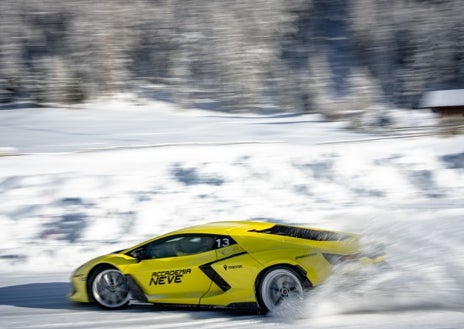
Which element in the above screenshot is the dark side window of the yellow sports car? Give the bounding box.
[143,234,216,259]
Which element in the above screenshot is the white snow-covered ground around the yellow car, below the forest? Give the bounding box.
[0,98,464,328]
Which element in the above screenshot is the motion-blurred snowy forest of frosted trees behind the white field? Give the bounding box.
[0,0,464,112]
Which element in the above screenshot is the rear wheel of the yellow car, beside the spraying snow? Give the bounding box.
[257,267,304,313]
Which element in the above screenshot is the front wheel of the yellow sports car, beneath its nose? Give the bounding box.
[90,269,130,310]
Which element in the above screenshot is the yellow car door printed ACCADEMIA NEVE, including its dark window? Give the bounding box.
[125,234,217,304]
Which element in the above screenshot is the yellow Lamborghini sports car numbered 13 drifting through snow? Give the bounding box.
[68,221,382,313]
